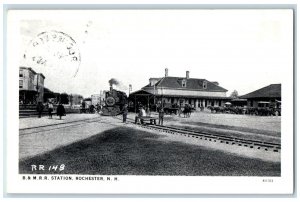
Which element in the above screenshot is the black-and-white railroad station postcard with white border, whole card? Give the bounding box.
[5,8,294,194]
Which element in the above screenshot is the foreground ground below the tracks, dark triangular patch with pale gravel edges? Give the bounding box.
[19,114,281,176]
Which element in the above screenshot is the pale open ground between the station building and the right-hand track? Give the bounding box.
[129,112,281,143]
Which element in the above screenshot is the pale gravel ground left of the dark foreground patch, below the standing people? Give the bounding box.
[19,116,115,159]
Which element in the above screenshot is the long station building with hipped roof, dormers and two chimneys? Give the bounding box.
[129,68,231,110]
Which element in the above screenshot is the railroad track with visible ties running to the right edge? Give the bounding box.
[111,116,281,152]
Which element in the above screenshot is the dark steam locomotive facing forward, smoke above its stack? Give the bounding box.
[102,87,127,116]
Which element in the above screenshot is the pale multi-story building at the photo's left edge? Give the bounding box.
[19,67,45,104]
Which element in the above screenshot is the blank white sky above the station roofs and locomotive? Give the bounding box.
[19,9,293,97]
